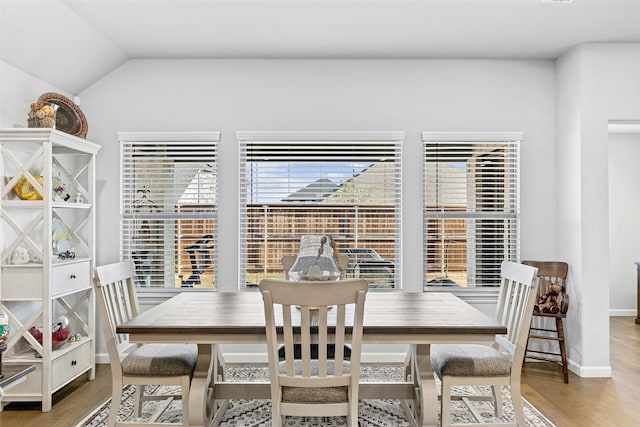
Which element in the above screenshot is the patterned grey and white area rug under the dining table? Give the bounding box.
[76,366,555,427]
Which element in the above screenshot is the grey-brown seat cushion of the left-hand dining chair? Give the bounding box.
[122,344,198,376]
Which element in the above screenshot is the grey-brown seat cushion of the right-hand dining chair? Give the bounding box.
[431,344,511,377]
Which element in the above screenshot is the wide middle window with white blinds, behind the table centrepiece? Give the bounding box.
[237,132,404,288]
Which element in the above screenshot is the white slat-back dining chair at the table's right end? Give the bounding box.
[431,261,538,427]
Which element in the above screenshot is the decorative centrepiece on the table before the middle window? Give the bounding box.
[289,235,340,281]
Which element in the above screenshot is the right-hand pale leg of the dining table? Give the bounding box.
[411,344,438,427]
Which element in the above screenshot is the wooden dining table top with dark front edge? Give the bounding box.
[117,291,506,336]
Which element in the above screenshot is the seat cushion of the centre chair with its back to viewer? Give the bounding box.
[279,360,351,403]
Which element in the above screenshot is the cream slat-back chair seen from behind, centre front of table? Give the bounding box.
[258,279,369,427]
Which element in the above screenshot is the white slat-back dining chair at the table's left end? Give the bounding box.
[95,260,198,427]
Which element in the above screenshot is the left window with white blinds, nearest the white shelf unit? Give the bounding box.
[118,132,220,288]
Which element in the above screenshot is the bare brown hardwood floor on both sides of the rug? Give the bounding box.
[0,317,640,427]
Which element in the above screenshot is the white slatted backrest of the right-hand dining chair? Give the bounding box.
[496,261,538,369]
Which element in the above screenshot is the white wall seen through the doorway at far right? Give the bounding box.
[609,133,640,316]
